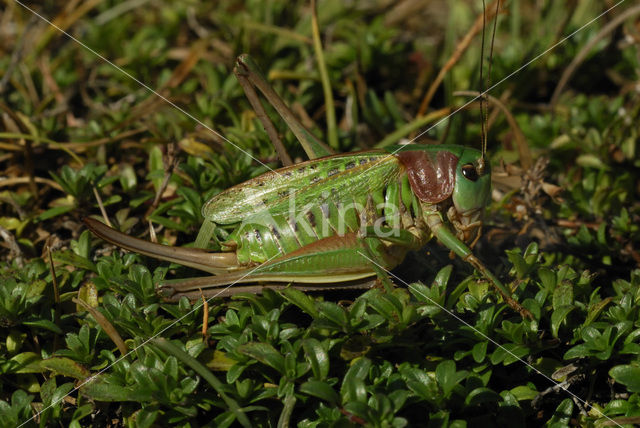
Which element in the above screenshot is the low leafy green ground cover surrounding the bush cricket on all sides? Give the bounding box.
[0,0,640,427]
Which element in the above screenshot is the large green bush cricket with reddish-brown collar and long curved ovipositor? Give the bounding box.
[85,55,531,317]
